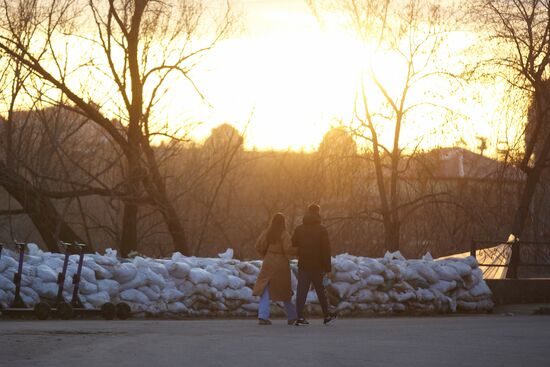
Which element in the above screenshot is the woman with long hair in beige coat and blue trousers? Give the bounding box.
[253,213,297,325]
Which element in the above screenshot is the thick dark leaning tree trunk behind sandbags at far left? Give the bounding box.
[0,162,84,252]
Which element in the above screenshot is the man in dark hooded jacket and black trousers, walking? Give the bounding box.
[292,204,336,325]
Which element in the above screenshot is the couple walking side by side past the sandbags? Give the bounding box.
[253,204,336,325]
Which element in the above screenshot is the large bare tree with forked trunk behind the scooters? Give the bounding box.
[0,0,232,255]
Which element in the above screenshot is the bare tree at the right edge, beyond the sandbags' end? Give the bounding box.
[472,0,550,276]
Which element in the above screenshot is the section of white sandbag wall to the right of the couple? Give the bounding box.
[326,252,493,313]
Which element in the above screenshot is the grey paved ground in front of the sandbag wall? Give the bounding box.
[0,315,550,367]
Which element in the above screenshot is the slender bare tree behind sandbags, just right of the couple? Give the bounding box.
[310,0,462,251]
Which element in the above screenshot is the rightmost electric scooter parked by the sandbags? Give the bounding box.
[71,243,132,320]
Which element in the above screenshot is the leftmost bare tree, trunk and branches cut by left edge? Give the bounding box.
[0,1,86,251]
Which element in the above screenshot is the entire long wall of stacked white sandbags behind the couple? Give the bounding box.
[0,244,493,316]
